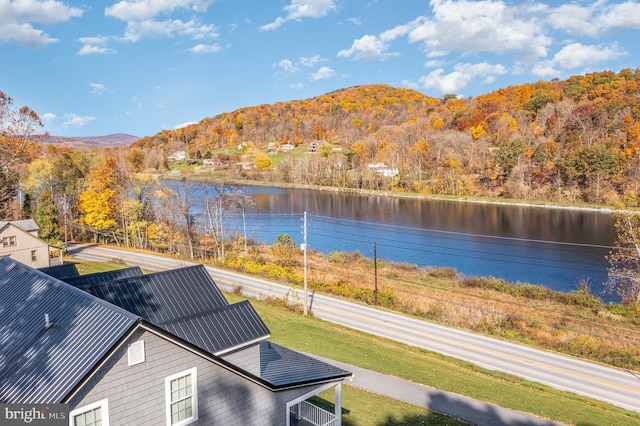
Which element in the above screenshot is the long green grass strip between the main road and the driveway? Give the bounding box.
[226,294,640,426]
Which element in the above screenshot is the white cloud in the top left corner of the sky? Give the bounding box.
[0,0,83,48]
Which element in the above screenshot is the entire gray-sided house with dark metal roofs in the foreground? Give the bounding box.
[0,257,352,426]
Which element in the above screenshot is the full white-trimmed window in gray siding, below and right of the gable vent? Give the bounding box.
[164,368,198,426]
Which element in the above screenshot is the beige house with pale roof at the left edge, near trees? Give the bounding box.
[0,219,62,268]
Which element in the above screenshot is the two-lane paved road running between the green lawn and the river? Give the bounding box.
[65,246,640,412]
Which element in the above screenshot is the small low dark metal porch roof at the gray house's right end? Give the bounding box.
[260,341,352,389]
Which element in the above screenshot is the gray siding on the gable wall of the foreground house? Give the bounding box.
[69,330,324,426]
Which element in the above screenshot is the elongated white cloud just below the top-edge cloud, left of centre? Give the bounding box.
[124,19,219,42]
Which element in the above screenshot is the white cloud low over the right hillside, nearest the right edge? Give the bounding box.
[532,43,627,77]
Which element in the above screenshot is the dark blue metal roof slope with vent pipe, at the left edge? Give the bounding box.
[0,257,139,404]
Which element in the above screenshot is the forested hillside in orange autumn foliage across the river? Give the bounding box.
[132,69,640,204]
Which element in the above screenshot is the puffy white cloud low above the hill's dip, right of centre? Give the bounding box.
[419,62,507,93]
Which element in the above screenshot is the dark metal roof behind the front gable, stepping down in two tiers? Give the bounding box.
[80,265,269,354]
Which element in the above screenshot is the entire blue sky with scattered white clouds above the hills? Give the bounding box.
[0,0,640,137]
